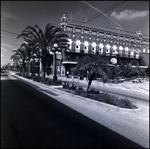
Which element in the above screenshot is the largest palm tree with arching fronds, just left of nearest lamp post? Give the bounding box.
[17,23,68,80]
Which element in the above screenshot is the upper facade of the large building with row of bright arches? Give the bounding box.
[61,16,149,62]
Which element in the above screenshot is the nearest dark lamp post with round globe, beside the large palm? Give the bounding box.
[53,43,58,84]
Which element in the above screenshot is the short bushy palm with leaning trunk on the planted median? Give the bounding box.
[75,55,109,91]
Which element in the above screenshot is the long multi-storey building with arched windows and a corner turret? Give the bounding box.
[48,15,149,75]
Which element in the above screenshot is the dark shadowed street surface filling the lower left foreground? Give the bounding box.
[1,76,141,148]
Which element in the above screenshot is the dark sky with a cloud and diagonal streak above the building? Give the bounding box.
[1,1,149,65]
